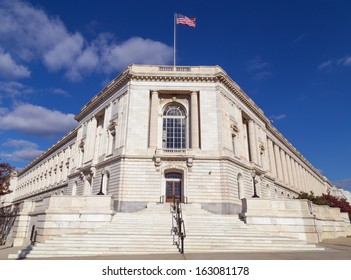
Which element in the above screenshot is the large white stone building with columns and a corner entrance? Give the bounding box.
[2,65,350,254]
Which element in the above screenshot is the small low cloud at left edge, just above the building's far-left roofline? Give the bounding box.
[0,139,43,162]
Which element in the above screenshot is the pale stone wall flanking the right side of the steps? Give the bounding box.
[241,199,351,243]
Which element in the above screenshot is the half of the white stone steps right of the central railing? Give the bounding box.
[182,202,324,253]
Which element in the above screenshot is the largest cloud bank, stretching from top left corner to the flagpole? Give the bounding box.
[0,0,172,81]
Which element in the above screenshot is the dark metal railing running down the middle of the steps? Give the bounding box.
[171,198,186,254]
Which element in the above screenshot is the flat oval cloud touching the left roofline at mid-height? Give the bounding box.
[0,104,76,136]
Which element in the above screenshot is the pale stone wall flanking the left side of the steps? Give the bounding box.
[13,196,114,246]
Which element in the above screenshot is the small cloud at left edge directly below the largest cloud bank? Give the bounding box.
[0,48,30,79]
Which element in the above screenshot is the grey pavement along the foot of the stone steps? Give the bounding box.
[0,237,351,260]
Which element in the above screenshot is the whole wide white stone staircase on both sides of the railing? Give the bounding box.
[9,204,322,259]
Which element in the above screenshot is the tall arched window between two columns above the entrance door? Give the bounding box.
[162,104,186,150]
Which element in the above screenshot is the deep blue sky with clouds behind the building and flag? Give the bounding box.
[0,0,351,190]
